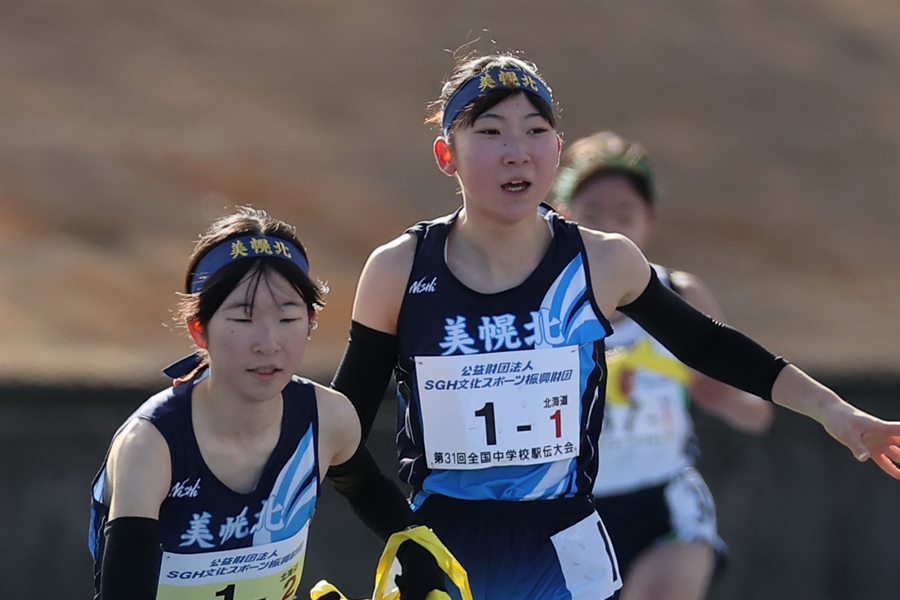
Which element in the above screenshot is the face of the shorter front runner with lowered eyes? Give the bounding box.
[206,271,309,401]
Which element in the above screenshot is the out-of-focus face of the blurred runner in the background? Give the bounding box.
[566,175,656,248]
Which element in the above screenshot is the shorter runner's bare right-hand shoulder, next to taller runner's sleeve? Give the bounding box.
[313,383,361,475]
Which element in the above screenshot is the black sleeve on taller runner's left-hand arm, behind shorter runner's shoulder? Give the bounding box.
[331,321,397,445]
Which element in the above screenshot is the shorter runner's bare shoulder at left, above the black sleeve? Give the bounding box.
[107,418,172,519]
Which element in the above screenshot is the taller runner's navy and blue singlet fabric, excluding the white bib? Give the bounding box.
[398,207,611,503]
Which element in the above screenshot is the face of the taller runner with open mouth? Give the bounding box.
[452,93,561,220]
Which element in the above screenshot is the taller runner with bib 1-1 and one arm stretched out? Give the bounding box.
[332,54,900,600]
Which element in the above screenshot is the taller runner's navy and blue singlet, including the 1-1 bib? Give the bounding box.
[397,206,611,507]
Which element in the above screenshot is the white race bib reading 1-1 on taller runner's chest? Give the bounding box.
[415,346,581,469]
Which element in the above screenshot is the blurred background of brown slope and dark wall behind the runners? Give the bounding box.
[0,0,900,600]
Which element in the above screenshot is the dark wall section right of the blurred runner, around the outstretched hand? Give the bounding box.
[697,376,900,600]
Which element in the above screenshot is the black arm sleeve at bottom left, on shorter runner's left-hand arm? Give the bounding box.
[100,517,162,600]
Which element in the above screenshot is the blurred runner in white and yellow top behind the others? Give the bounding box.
[555,131,773,600]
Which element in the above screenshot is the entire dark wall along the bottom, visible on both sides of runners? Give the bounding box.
[0,377,900,600]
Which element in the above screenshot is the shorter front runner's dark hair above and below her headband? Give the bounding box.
[176,206,327,336]
